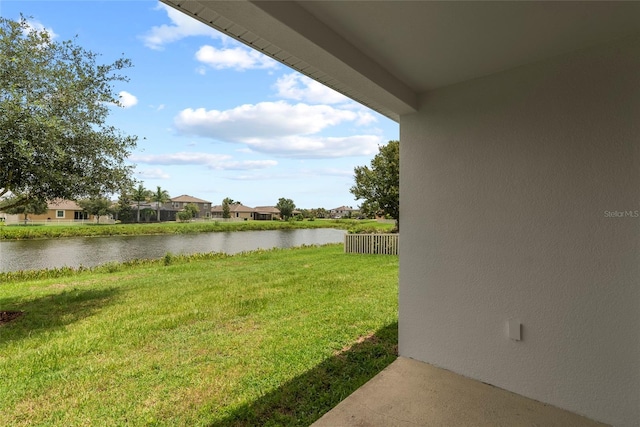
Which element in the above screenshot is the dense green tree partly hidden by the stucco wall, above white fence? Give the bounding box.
[349,141,400,231]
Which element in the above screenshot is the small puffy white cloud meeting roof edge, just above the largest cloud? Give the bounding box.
[275,73,352,104]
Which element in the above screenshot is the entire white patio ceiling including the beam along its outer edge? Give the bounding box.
[161,0,640,121]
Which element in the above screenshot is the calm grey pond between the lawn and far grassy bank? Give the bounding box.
[0,228,345,272]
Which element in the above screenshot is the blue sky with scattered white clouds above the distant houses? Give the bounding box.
[0,0,399,209]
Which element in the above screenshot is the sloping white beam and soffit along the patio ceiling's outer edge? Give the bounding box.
[161,0,418,121]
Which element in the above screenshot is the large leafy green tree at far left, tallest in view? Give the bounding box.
[0,17,137,210]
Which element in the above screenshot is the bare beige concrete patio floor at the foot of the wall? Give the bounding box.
[312,357,605,427]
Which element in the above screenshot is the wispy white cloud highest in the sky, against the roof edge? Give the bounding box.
[140,3,221,50]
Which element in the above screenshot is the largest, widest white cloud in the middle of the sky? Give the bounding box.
[174,101,381,158]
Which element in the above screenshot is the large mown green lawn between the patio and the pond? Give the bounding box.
[0,245,398,427]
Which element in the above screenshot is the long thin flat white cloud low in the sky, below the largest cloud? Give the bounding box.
[129,152,278,170]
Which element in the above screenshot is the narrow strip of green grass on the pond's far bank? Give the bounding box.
[0,220,393,240]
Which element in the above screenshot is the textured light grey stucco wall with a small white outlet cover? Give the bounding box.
[400,39,640,426]
